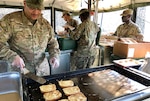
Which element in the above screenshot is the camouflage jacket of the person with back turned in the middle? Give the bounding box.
[70,19,99,57]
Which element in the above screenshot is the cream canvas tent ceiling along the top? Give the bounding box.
[0,0,150,12]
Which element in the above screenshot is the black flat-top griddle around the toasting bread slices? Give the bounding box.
[24,64,150,101]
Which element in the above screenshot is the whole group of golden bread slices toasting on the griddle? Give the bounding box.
[40,80,87,101]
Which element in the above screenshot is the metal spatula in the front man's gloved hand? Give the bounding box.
[22,68,46,84]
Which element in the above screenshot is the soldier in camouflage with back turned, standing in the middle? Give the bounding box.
[70,9,99,70]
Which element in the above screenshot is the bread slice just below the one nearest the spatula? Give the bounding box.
[43,90,62,101]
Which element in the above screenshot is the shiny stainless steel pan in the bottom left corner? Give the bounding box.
[0,72,23,101]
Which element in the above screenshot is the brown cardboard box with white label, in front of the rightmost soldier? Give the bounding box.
[113,41,150,58]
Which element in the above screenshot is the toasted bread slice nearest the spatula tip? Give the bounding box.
[39,84,56,93]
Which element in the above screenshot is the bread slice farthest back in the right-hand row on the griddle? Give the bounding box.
[58,80,74,88]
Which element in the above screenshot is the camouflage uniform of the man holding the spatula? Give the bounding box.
[0,11,59,75]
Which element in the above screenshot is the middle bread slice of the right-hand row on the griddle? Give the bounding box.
[63,86,80,96]
